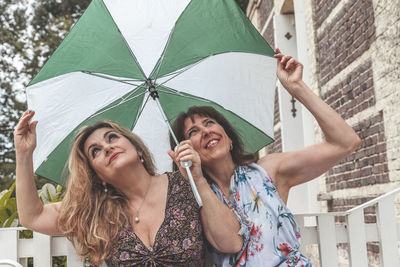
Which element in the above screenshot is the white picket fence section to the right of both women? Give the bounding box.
[294,188,400,267]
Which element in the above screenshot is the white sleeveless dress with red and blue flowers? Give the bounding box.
[211,163,311,267]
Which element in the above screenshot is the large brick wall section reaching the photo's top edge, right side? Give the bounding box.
[314,0,375,85]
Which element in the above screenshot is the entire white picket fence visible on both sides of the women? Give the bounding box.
[0,188,400,267]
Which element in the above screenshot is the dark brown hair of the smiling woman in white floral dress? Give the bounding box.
[170,106,256,173]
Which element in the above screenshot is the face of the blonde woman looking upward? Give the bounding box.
[84,128,141,184]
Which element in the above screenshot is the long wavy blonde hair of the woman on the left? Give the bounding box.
[57,121,155,265]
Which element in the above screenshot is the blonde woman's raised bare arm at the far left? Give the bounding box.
[14,111,61,235]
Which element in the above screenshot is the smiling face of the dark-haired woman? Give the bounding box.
[184,114,232,167]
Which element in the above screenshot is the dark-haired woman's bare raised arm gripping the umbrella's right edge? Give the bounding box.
[258,49,361,201]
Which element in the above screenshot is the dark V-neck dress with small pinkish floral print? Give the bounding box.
[106,171,204,267]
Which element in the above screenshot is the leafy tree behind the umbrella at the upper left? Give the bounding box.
[0,0,90,191]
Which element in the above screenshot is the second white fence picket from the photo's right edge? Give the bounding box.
[346,209,368,267]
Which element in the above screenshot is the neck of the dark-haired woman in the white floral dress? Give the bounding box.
[204,154,235,194]
